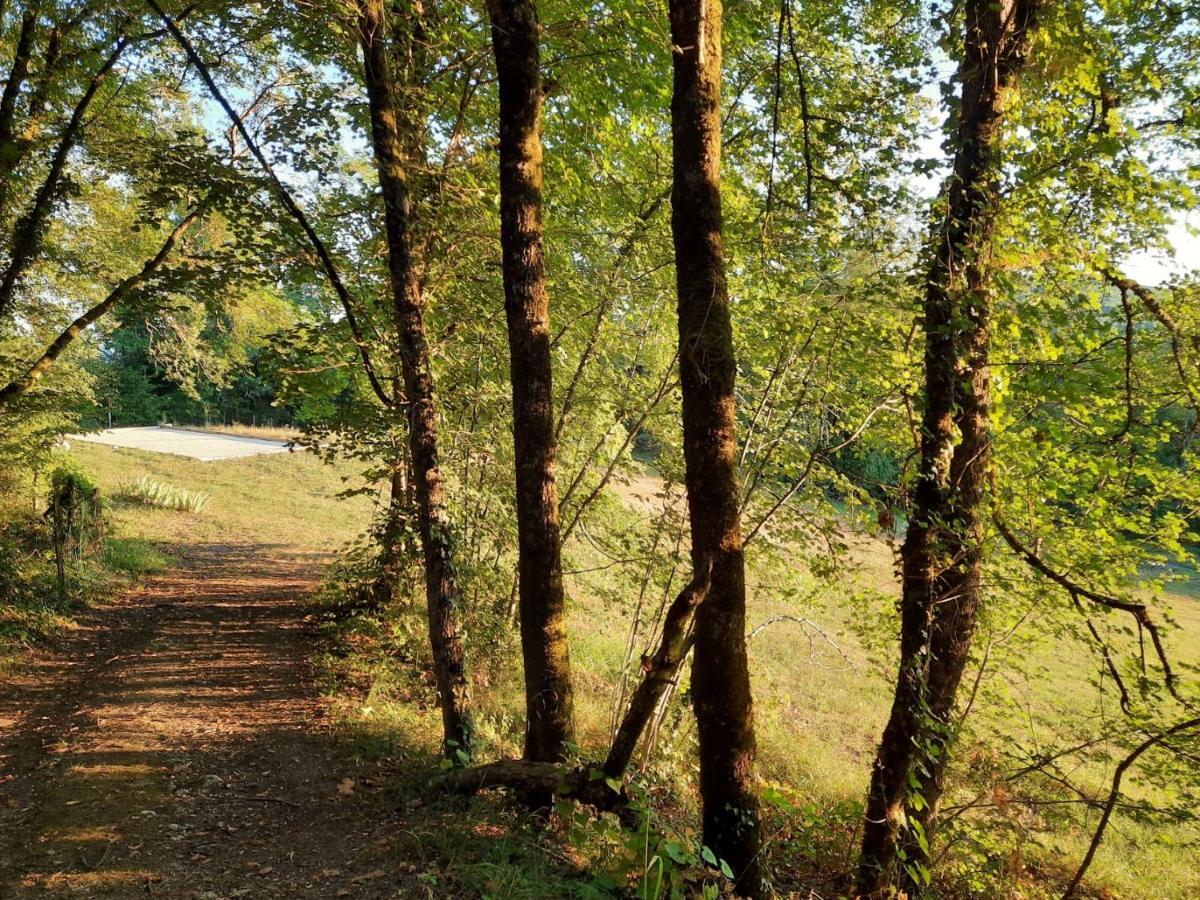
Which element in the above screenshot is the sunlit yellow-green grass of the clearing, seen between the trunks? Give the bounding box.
[37,445,1200,900]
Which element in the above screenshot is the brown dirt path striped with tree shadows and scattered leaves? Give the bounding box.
[0,545,427,900]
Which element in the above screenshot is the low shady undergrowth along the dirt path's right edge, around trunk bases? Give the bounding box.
[311,582,758,900]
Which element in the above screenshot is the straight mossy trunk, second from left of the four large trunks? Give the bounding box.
[487,0,575,761]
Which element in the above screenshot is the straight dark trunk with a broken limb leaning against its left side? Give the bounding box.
[670,0,763,895]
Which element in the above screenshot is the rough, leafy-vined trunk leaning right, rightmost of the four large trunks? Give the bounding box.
[856,0,1038,896]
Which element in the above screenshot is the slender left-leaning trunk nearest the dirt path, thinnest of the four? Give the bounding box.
[358,0,472,763]
